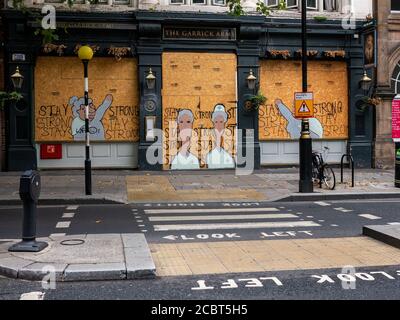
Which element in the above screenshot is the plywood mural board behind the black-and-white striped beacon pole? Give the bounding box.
[35,57,139,142]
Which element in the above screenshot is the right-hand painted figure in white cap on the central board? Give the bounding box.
[206,104,235,169]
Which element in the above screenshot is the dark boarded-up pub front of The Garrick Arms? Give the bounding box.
[3,0,374,170]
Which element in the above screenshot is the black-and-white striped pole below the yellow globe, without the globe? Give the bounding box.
[82,60,92,195]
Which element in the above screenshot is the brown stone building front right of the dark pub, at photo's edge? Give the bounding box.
[375,0,400,168]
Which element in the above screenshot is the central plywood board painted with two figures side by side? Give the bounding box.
[163,53,236,170]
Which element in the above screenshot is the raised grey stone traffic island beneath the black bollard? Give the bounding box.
[0,234,155,281]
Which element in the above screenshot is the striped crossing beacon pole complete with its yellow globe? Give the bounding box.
[78,46,93,195]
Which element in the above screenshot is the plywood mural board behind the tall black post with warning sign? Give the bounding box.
[259,60,348,140]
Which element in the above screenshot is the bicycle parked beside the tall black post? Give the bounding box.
[312,147,336,190]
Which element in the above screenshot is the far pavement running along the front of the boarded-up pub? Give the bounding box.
[0,168,400,205]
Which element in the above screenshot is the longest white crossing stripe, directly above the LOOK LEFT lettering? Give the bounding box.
[154,221,321,231]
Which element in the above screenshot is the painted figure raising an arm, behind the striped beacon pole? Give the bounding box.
[69,94,113,141]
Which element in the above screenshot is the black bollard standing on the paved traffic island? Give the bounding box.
[8,170,48,252]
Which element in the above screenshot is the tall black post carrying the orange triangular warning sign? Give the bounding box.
[299,0,314,193]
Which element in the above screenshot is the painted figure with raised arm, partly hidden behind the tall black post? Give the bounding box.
[275,99,324,139]
